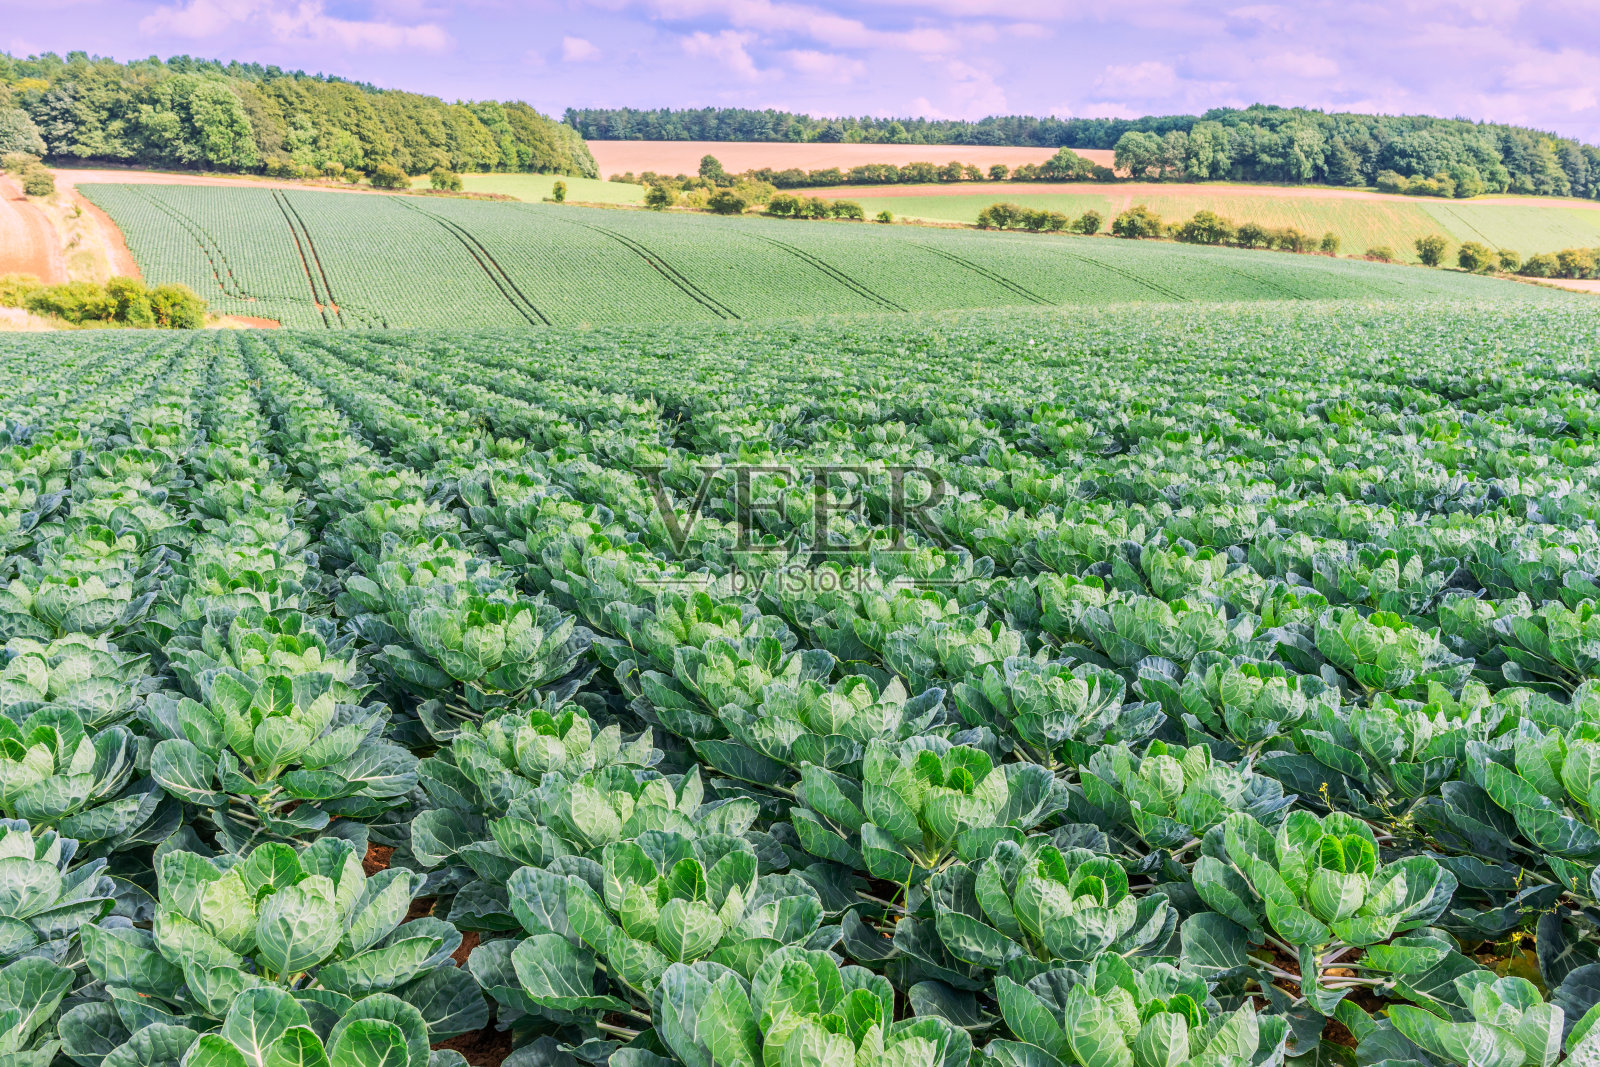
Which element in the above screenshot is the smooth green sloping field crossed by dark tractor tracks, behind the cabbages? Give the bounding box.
[82,186,1571,328]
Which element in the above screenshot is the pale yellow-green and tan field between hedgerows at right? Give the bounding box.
[851,186,1600,262]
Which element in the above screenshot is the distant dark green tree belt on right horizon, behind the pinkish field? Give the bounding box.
[565,104,1600,198]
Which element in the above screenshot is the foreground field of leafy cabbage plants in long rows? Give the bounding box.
[9,299,1600,1067]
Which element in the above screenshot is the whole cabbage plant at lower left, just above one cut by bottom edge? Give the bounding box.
[61,838,488,1062]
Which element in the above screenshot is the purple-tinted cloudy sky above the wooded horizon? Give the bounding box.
[0,0,1600,142]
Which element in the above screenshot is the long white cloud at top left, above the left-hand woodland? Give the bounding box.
[139,0,451,51]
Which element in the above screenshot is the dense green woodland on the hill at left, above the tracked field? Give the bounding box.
[0,51,597,178]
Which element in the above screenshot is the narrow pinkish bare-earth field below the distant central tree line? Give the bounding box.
[589,141,1112,178]
